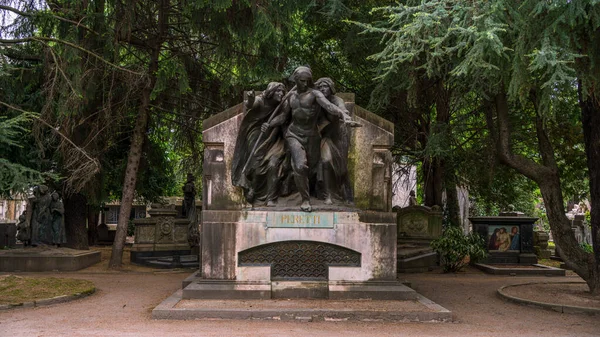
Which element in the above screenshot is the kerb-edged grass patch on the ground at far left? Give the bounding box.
[0,275,95,304]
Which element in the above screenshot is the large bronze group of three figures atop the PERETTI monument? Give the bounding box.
[232,67,360,212]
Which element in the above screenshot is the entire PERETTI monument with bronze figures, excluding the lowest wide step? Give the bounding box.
[182,67,417,300]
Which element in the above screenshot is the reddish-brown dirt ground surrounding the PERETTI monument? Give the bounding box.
[0,248,600,337]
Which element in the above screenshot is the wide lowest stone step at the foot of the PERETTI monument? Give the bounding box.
[152,290,452,322]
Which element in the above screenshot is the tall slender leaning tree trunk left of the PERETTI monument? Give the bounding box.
[108,0,168,269]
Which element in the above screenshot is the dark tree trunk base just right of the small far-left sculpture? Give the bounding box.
[63,193,90,249]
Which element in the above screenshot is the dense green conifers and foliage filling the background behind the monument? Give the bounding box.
[0,0,600,292]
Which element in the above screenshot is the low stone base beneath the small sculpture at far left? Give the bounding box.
[0,246,100,272]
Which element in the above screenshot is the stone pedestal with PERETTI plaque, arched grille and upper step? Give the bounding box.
[183,211,416,299]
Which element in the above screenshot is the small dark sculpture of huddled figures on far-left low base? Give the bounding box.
[17,185,67,247]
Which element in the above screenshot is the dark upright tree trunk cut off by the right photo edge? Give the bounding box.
[578,82,600,294]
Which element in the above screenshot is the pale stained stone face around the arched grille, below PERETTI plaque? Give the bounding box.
[202,211,396,281]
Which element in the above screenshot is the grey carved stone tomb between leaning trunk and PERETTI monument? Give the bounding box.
[131,204,190,264]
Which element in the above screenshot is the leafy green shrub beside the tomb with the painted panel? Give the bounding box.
[431,226,487,273]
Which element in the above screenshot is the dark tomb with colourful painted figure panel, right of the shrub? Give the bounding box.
[469,211,538,264]
